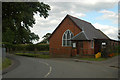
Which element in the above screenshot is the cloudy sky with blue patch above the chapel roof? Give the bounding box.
[31,0,118,43]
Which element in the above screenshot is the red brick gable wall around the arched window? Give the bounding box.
[50,17,81,57]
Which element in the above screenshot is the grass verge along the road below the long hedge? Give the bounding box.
[16,53,50,59]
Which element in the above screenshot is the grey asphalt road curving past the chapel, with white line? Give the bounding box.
[3,55,118,78]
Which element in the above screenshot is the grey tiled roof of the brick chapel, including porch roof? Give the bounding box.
[68,15,109,40]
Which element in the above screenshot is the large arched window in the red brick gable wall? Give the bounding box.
[62,29,74,46]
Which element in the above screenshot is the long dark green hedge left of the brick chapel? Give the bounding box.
[3,43,49,51]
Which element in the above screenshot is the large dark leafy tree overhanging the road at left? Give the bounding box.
[2,2,50,44]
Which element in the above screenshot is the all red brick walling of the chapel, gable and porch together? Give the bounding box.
[49,17,94,57]
